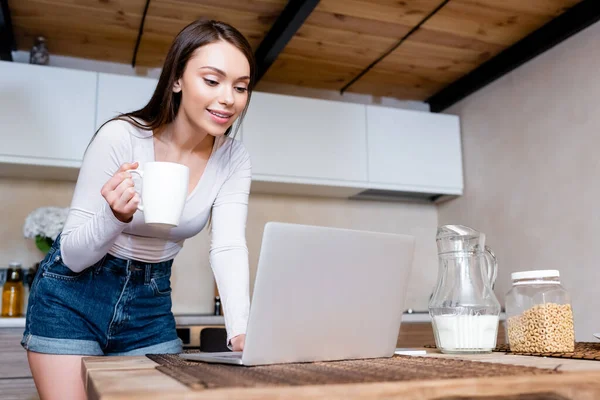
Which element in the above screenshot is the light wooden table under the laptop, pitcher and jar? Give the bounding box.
[82,349,600,400]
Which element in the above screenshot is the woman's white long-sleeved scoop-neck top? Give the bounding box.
[60,120,251,341]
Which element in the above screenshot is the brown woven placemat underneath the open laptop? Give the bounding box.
[147,354,560,390]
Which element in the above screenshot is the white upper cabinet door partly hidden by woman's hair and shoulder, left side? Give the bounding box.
[96,73,158,129]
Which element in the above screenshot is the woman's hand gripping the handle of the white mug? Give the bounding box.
[100,162,140,222]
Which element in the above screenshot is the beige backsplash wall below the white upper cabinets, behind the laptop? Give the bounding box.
[0,178,437,314]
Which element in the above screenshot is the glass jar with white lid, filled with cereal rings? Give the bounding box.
[506,270,575,353]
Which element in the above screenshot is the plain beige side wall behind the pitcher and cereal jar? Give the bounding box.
[439,23,600,341]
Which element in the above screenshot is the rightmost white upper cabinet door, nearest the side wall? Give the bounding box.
[367,106,463,194]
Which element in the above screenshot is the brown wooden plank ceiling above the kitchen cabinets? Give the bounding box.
[8,0,581,100]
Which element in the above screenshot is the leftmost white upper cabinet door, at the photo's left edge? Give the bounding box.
[0,62,97,165]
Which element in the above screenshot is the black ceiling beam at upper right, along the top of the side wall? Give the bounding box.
[425,0,600,112]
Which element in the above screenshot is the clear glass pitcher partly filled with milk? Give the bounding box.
[429,225,500,354]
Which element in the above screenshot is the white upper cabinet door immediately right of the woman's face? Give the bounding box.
[242,92,367,182]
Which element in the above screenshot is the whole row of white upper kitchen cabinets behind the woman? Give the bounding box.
[0,62,463,201]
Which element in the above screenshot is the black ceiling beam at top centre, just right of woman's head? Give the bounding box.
[254,0,320,82]
